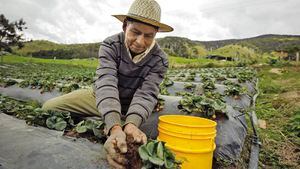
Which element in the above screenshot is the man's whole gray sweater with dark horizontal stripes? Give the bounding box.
[94,32,168,132]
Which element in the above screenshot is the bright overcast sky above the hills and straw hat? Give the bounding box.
[0,0,300,44]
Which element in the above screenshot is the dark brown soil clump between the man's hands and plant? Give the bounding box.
[125,136,143,169]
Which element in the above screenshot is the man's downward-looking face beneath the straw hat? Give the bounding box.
[124,21,157,54]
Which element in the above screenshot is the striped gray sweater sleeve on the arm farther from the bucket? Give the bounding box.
[95,41,121,134]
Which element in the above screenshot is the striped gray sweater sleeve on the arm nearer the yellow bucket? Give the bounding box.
[125,53,168,127]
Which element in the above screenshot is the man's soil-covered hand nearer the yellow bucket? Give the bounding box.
[124,123,147,144]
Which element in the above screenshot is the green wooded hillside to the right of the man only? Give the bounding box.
[157,34,300,57]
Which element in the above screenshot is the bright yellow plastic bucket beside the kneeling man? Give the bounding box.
[158,115,217,169]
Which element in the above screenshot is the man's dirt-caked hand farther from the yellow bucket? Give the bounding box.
[104,126,127,169]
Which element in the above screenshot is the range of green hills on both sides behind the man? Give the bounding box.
[15,34,300,59]
